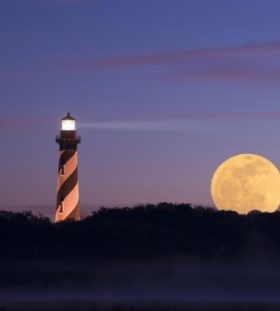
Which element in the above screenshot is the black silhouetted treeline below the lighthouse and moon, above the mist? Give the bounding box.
[0,203,280,260]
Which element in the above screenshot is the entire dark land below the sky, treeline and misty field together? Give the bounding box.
[0,203,280,310]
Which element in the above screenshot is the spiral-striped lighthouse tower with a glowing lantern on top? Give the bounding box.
[55,112,81,222]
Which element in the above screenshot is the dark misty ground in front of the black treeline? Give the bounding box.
[0,260,280,311]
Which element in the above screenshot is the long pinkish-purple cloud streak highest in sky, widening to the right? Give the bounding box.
[3,42,280,83]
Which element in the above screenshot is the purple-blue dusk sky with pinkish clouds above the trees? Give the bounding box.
[0,0,280,215]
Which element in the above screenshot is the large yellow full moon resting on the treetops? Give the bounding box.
[211,154,280,214]
